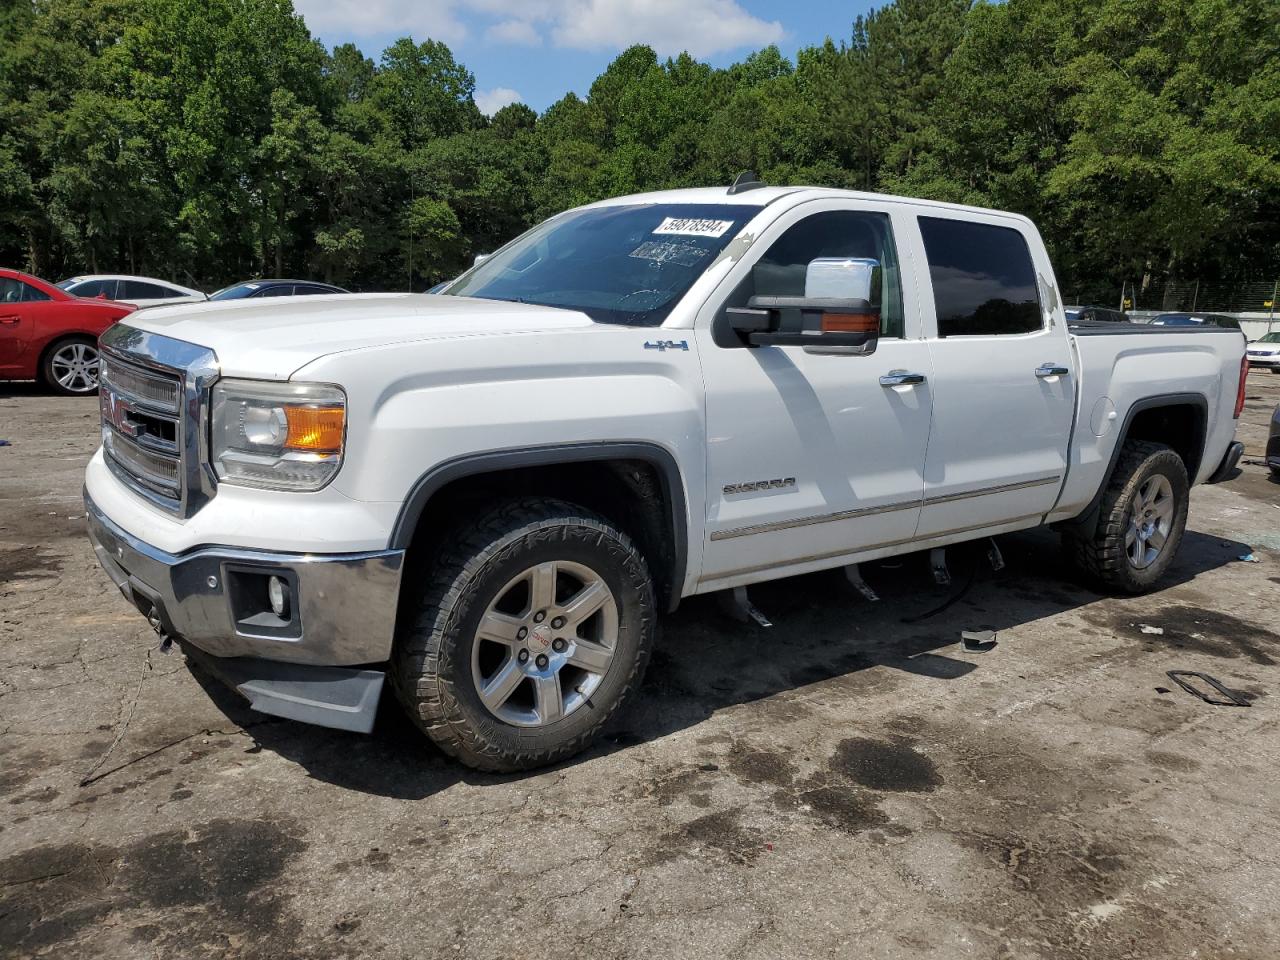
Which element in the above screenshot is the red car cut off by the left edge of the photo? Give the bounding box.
[0,270,134,396]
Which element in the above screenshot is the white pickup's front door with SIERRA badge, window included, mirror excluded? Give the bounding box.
[696,200,933,590]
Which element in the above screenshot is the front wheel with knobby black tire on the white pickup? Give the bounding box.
[392,498,657,772]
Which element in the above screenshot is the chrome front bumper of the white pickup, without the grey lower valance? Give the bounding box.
[84,493,404,667]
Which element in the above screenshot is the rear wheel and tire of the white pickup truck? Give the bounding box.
[1064,440,1190,594]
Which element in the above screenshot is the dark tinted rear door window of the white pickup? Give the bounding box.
[920,216,1043,337]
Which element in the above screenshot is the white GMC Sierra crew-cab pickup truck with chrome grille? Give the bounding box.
[84,180,1247,771]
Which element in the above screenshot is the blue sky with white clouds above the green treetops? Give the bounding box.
[294,0,873,113]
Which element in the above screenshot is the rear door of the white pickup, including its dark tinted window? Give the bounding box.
[916,210,1075,539]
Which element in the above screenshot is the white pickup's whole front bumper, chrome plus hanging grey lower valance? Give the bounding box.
[84,492,404,731]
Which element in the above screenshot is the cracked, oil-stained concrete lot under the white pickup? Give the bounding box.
[0,374,1280,960]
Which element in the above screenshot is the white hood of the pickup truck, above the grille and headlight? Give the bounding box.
[120,293,594,379]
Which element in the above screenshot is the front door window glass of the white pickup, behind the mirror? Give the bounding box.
[744,210,904,337]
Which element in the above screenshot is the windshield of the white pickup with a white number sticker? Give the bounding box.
[442,204,762,326]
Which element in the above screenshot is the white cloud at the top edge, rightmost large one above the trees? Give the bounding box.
[552,0,785,56]
